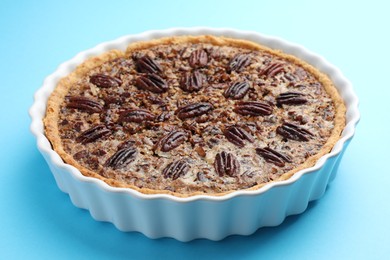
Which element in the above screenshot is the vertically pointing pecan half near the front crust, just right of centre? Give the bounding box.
[214,151,240,177]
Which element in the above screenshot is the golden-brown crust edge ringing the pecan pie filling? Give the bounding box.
[43,35,346,197]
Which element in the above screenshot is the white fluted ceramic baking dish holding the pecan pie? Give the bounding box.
[30,28,359,241]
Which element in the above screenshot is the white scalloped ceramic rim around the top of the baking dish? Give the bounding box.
[29,27,360,203]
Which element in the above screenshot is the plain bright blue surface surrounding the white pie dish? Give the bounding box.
[0,0,390,259]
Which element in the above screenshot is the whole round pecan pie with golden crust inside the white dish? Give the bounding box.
[44,35,345,197]
